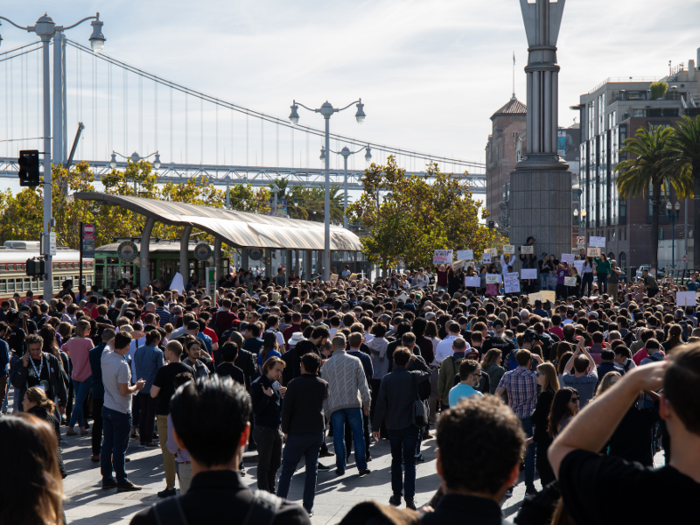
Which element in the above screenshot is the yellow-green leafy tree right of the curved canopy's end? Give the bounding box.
[348,157,494,268]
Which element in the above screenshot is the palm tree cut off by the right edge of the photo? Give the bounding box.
[669,116,700,268]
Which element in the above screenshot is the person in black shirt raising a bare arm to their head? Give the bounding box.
[548,345,700,524]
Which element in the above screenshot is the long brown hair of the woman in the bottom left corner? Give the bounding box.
[0,412,65,525]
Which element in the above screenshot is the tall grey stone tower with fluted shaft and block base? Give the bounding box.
[510,0,572,259]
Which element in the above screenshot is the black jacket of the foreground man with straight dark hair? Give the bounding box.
[131,470,311,525]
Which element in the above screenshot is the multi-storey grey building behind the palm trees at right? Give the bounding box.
[572,55,700,268]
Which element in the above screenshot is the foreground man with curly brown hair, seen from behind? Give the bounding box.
[423,396,525,525]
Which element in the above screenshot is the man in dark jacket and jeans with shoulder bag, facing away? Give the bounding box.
[372,346,430,510]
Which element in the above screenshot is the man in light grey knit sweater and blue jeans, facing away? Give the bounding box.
[321,334,370,476]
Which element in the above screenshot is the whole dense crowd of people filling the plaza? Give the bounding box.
[0,262,700,525]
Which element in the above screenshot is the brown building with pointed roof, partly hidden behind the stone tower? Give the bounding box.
[486,94,527,230]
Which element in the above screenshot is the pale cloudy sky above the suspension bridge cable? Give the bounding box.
[0,0,700,195]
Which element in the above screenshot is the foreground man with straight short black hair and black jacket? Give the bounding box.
[131,376,311,525]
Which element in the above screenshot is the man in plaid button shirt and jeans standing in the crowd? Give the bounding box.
[496,330,542,495]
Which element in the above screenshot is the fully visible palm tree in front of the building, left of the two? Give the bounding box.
[615,126,691,269]
